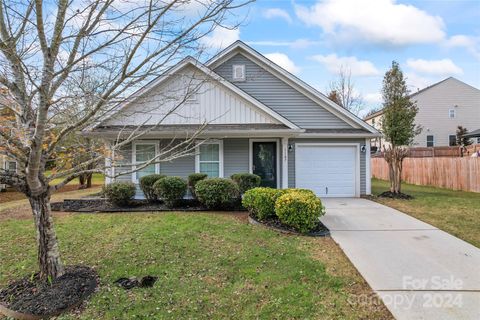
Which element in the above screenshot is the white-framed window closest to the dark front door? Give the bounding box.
[195,141,223,178]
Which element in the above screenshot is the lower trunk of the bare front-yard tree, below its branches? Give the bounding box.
[29,193,64,280]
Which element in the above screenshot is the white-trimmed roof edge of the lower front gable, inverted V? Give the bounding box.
[88,56,300,130]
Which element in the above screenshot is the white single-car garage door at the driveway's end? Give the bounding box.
[295,144,358,197]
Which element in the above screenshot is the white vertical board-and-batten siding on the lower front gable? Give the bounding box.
[104,67,280,126]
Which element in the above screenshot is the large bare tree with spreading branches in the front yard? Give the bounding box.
[0,0,250,279]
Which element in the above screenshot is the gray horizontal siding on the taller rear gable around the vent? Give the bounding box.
[214,54,351,128]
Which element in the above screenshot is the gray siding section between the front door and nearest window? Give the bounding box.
[223,139,249,178]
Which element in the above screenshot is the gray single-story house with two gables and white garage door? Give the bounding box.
[84,41,380,197]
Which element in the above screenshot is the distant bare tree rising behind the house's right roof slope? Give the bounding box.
[327,67,363,115]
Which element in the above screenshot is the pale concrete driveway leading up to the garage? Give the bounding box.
[322,199,480,320]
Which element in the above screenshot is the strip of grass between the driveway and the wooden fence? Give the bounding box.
[372,179,480,248]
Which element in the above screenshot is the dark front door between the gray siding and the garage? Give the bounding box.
[252,141,277,188]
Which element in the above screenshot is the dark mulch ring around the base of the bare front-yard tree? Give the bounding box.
[0,266,98,319]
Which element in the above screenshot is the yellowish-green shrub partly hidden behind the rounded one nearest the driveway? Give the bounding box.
[242,188,287,220]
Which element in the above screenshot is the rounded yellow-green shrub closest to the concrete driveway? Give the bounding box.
[275,190,324,233]
